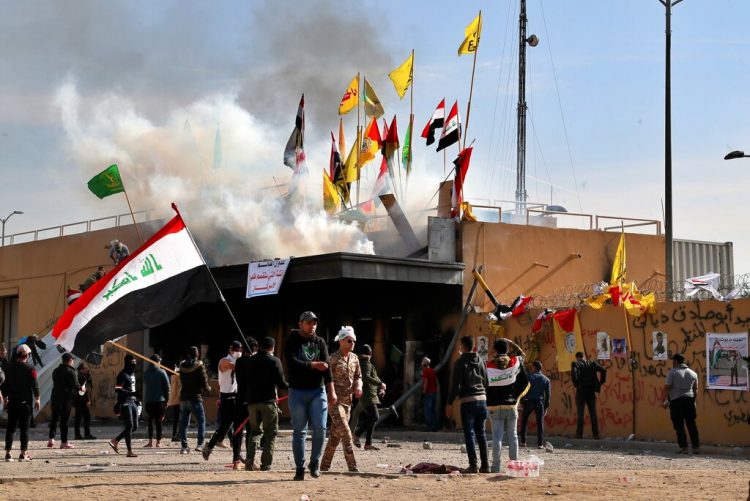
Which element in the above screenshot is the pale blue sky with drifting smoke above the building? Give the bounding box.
[0,0,750,273]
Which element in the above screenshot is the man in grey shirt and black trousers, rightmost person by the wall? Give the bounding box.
[664,353,700,454]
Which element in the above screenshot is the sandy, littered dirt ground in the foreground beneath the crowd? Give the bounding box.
[0,428,750,500]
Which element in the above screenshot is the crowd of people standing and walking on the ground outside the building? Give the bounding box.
[0,311,716,480]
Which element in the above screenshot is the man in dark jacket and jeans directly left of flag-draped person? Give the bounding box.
[445,336,490,473]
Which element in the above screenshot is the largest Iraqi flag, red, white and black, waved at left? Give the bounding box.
[52,207,222,357]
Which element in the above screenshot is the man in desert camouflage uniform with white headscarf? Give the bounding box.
[320,325,362,472]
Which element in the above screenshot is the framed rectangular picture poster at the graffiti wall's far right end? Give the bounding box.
[706,332,750,391]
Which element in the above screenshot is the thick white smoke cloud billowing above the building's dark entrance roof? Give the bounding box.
[56,80,374,265]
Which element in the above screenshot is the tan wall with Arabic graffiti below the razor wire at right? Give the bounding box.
[454,300,750,446]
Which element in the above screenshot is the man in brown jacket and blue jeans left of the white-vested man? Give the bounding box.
[180,346,211,454]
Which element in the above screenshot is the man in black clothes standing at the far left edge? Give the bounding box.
[3,345,40,461]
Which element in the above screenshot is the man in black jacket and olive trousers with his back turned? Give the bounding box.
[244,337,289,471]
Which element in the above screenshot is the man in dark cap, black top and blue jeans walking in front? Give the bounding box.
[284,311,336,480]
